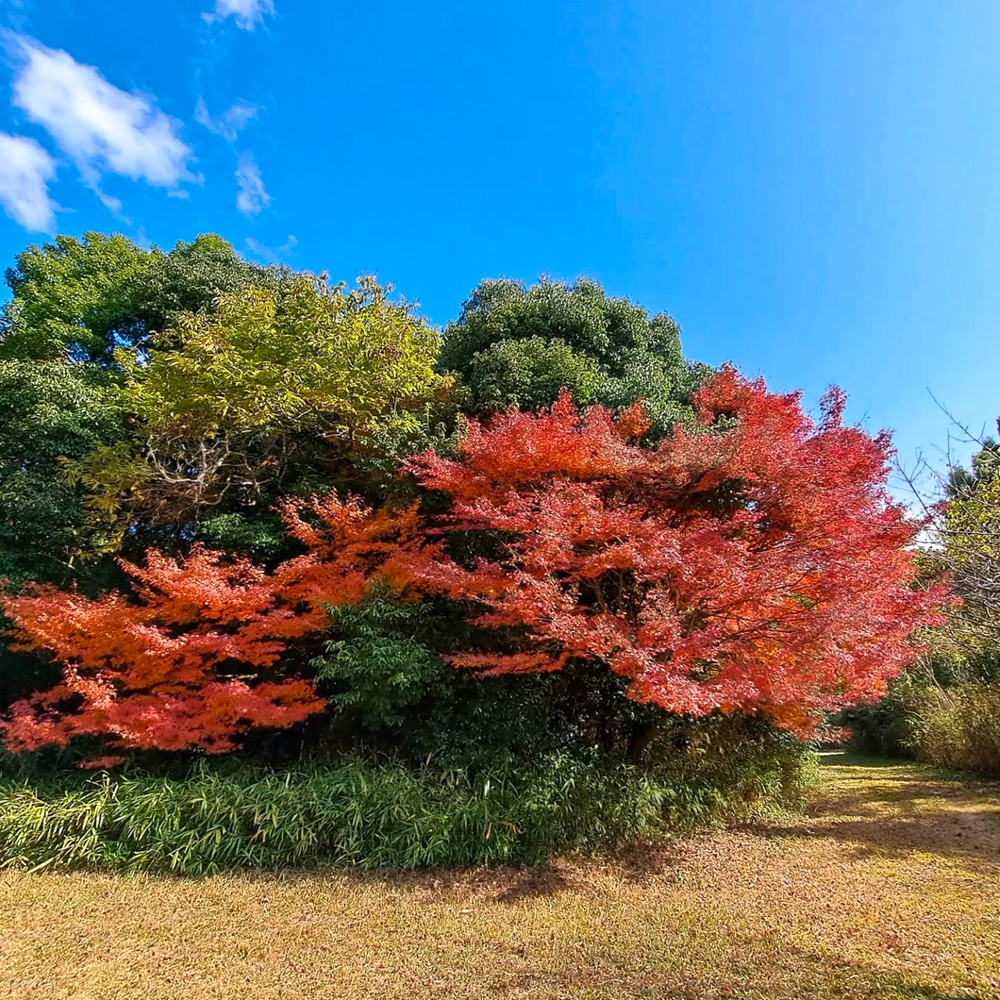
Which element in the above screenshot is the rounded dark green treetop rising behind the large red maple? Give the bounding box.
[441,278,708,436]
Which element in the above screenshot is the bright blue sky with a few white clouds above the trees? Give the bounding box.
[0,0,1000,484]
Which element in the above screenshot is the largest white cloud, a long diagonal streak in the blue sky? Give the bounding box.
[7,33,201,199]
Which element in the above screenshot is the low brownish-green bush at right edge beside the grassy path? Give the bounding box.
[912,683,1000,775]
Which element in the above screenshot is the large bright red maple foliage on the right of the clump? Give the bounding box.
[409,368,944,730]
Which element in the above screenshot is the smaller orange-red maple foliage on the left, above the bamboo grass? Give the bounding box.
[3,493,426,765]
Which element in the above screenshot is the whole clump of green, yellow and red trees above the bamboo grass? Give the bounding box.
[0,233,945,860]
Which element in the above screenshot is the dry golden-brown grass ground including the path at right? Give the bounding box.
[0,755,1000,1000]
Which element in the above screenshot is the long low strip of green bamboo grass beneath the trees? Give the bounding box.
[0,744,804,874]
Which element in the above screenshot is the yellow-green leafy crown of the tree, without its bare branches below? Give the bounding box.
[119,277,448,437]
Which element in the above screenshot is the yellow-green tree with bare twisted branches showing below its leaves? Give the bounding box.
[74,276,450,552]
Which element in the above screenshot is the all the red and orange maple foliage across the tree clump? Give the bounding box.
[2,368,945,763]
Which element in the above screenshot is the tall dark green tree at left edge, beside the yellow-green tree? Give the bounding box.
[0,233,287,702]
